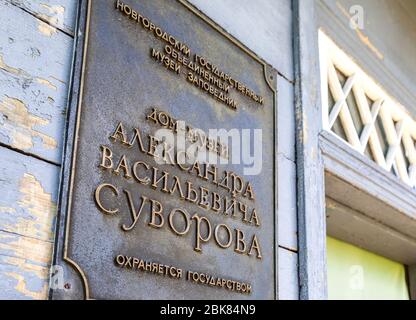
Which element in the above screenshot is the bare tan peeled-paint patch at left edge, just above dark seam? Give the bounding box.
[0,97,57,150]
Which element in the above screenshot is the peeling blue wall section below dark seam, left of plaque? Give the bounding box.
[0,147,59,299]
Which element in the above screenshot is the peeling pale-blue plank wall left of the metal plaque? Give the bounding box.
[0,0,76,299]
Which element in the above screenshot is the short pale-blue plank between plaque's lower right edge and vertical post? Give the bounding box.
[279,248,299,300]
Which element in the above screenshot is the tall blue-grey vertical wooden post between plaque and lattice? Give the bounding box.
[293,0,327,300]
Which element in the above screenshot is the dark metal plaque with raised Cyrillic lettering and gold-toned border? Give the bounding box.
[51,0,277,299]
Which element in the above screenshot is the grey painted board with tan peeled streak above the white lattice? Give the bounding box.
[315,0,416,116]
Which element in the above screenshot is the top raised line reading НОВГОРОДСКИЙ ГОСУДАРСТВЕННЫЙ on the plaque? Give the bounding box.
[115,0,264,105]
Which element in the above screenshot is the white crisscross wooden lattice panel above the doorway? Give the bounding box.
[319,32,416,188]
